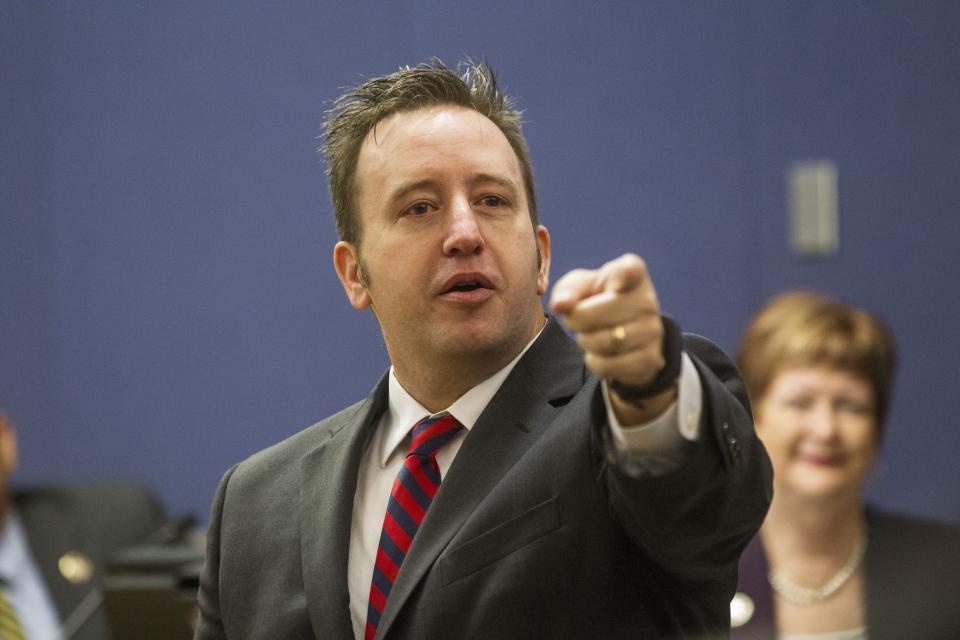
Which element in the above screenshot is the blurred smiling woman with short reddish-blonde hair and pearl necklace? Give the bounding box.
[731,292,960,640]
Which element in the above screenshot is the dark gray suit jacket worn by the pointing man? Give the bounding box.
[196,320,771,640]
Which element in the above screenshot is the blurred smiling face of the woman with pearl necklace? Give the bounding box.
[756,366,878,498]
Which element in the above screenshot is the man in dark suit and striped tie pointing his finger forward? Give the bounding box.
[197,63,770,639]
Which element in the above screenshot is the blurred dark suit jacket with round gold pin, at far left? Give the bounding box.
[13,482,164,640]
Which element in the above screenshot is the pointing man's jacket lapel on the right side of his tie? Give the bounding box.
[377,319,584,638]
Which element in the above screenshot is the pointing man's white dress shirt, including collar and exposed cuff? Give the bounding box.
[347,329,702,640]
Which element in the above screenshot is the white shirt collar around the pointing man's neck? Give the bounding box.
[379,322,547,467]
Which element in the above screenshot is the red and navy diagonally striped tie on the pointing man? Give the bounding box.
[364,415,463,640]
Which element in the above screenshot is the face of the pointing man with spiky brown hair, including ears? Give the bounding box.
[334,105,550,370]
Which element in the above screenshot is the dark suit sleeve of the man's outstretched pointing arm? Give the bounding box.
[598,334,772,584]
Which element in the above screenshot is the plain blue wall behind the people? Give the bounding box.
[0,0,960,520]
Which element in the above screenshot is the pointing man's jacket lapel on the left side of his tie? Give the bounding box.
[300,376,387,638]
